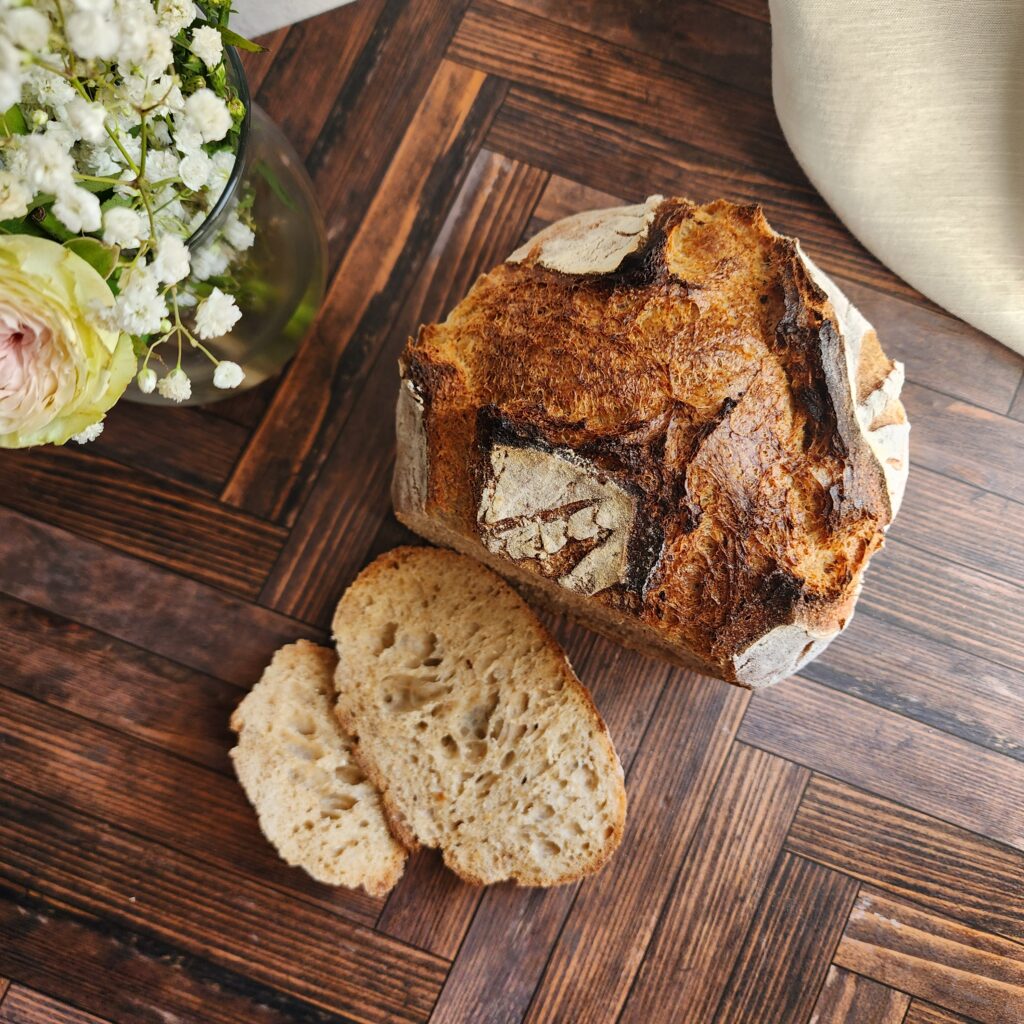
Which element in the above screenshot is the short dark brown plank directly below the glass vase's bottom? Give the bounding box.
[86,399,248,495]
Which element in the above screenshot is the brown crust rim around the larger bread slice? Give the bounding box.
[333,546,627,886]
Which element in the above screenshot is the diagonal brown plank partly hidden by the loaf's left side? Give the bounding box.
[261,153,546,625]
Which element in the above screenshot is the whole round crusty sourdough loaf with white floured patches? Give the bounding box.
[392,197,909,687]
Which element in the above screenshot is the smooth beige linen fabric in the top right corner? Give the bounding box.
[771,0,1024,353]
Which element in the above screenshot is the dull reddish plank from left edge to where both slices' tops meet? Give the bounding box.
[0,509,323,686]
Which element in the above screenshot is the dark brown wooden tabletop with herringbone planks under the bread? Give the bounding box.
[0,0,1024,1024]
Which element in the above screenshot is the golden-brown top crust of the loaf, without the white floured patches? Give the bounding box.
[402,200,903,672]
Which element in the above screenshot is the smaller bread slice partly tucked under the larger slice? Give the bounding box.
[231,640,406,896]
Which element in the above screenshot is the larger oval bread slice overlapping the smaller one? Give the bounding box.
[334,548,626,886]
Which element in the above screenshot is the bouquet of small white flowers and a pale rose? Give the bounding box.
[0,0,268,447]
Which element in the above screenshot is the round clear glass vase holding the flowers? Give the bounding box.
[124,49,327,406]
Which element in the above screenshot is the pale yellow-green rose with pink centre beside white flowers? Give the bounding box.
[0,241,135,447]
